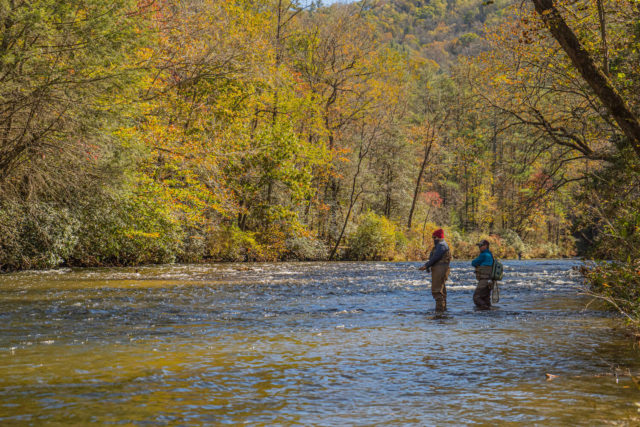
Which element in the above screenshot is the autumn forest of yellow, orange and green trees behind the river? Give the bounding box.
[0,0,640,321]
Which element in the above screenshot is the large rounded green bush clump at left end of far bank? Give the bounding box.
[0,194,183,270]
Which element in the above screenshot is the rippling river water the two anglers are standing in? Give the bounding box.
[0,261,640,426]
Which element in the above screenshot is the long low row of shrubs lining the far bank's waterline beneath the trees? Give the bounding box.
[0,208,574,271]
